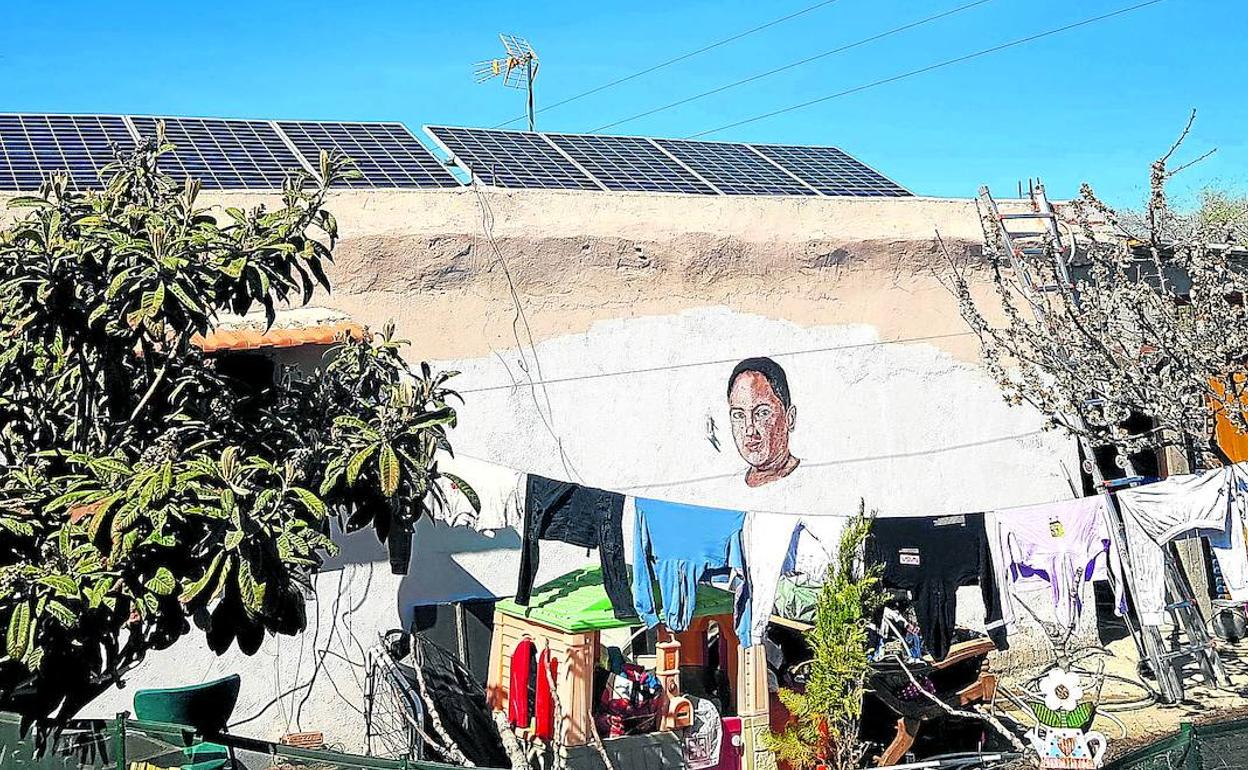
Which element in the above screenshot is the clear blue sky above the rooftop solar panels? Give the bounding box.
[0,0,1248,206]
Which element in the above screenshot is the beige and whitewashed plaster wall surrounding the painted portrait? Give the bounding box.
[2,190,1093,749]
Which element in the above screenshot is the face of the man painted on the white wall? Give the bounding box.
[728,372,796,470]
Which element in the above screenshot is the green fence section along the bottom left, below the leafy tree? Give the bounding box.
[0,714,469,770]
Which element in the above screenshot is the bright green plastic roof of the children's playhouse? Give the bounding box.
[495,567,733,634]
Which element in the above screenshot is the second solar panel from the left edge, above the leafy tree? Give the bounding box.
[131,116,306,190]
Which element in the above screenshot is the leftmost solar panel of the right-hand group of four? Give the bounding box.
[424,126,602,190]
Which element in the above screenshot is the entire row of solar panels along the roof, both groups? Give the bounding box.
[0,115,910,197]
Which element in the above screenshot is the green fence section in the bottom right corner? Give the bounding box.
[1104,719,1248,770]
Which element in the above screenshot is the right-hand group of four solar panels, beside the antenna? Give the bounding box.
[424,126,910,197]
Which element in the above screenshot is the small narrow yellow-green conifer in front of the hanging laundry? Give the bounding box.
[769,509,882,770]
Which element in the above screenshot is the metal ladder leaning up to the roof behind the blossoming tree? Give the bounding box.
[977,183,1231,703]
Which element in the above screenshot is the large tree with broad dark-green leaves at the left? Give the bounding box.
[0,129,471,719]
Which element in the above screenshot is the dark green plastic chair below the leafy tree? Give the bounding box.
[135,674,242,770]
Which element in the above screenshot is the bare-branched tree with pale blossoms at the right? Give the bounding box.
[950,114,1248,464]
